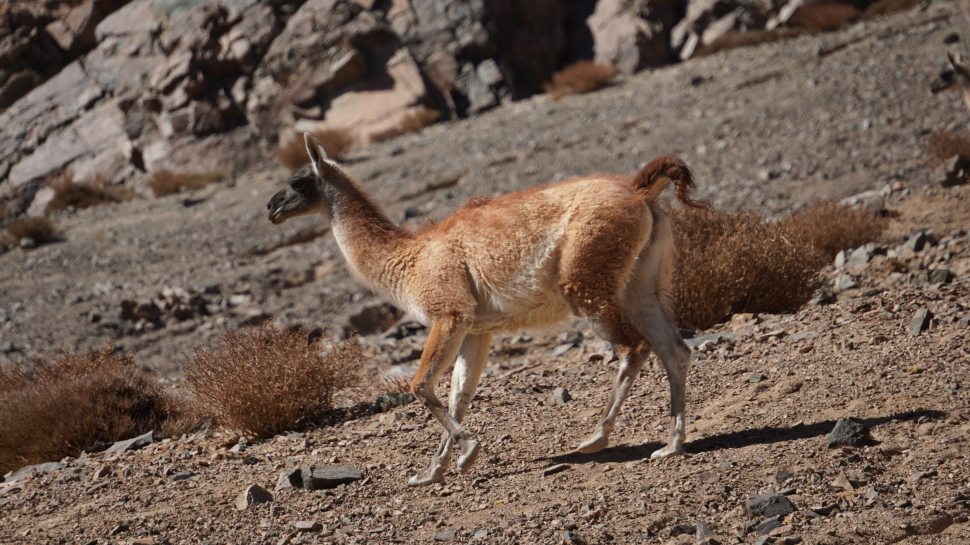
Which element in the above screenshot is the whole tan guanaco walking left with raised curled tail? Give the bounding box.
[267,134,699,485]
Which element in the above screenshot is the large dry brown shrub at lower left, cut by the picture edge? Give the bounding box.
[0,344,179,473]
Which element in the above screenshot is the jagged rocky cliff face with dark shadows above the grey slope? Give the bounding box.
[0,0,908,214]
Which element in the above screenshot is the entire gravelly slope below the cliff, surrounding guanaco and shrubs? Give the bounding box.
[0,1,970,544]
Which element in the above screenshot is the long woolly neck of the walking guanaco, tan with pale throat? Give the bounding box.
[324,172,408,291]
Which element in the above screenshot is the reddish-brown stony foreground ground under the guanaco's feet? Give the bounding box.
[0,184,970,545]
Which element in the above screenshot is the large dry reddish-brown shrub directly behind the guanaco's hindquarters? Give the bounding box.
[668,207,828,329]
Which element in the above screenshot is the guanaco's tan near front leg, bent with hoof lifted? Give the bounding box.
[408,316,478,486]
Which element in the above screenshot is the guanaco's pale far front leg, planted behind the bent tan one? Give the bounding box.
[408,334,491,486]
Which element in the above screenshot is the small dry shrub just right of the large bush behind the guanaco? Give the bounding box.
[781,202,889,260]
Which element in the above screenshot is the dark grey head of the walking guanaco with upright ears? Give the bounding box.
[266,133,340,225]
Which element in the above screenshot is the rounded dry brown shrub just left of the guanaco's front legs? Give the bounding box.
[183,325,364,438]
